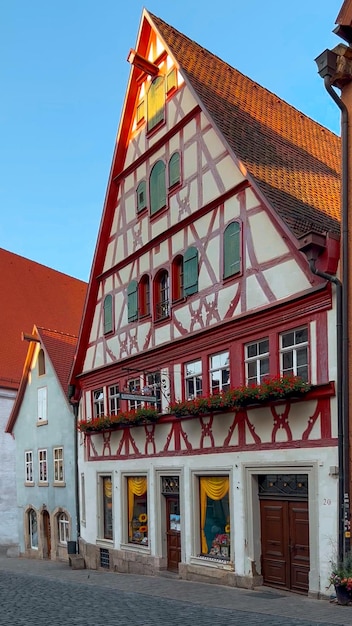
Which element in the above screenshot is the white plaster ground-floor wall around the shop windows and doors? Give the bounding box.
[79,438,338,593]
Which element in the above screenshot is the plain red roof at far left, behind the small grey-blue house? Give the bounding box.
[0,248,87,389]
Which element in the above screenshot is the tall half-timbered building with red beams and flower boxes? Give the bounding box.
[71,10,340,596]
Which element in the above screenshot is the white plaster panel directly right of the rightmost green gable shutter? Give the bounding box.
[249,210,289,263]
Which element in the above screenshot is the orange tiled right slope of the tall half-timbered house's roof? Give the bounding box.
[149,13,340,236]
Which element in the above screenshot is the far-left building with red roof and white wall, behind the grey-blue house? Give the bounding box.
[0,248,87,553]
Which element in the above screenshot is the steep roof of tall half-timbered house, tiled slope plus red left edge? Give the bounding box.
[72,10,340,381]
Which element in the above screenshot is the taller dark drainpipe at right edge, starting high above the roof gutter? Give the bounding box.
[324,75,350,558]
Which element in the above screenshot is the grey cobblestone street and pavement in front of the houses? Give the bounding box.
[0,557,352,626]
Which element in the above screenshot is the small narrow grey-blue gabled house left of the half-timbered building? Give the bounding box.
[6,326,77,559]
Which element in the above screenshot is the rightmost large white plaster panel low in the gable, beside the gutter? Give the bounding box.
[263,259,311,300]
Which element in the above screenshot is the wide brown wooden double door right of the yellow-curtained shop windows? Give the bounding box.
[260,500,309,593]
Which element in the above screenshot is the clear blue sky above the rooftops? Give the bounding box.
[0,0,342,280]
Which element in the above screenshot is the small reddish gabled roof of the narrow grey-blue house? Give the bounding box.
[5,326,77,433]
